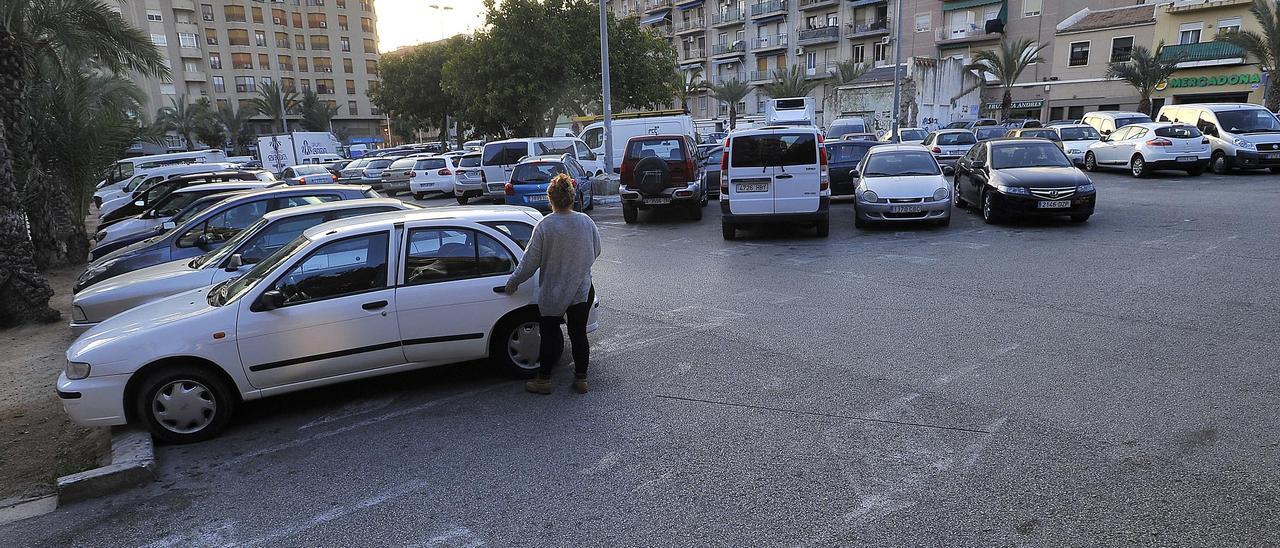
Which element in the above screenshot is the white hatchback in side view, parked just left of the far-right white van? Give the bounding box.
[1084,122,1212,178]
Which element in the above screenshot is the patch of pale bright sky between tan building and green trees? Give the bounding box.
[374,0,484,52]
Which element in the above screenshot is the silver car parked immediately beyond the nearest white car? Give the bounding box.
[72,198,419,333]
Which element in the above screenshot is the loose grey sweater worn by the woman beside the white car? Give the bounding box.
[507,211,600,316]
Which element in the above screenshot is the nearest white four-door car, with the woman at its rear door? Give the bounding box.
[56,207,598,443]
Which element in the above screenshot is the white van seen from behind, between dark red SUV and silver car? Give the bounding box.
[721,125,831,239]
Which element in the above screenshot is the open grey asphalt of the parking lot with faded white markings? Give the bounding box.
[10,173,1280,547]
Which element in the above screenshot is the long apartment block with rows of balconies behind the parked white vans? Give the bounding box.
[609,0,1135,123]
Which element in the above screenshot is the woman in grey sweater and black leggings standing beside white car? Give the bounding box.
[507,173,600,394]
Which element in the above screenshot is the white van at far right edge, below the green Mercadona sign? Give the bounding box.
[1156,102,1280,173]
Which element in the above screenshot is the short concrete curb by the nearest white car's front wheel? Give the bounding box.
[58,429,156,503]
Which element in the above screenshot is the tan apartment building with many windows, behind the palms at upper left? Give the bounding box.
[115,0,387,149]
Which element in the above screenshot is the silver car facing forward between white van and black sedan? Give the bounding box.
[854,145,951,228]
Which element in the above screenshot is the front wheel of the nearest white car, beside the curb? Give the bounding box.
[134,365,238,443]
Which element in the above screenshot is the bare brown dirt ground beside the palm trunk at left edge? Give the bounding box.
[0,266,110,501]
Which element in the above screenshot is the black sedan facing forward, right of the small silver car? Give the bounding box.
[954,138,1097,223]
